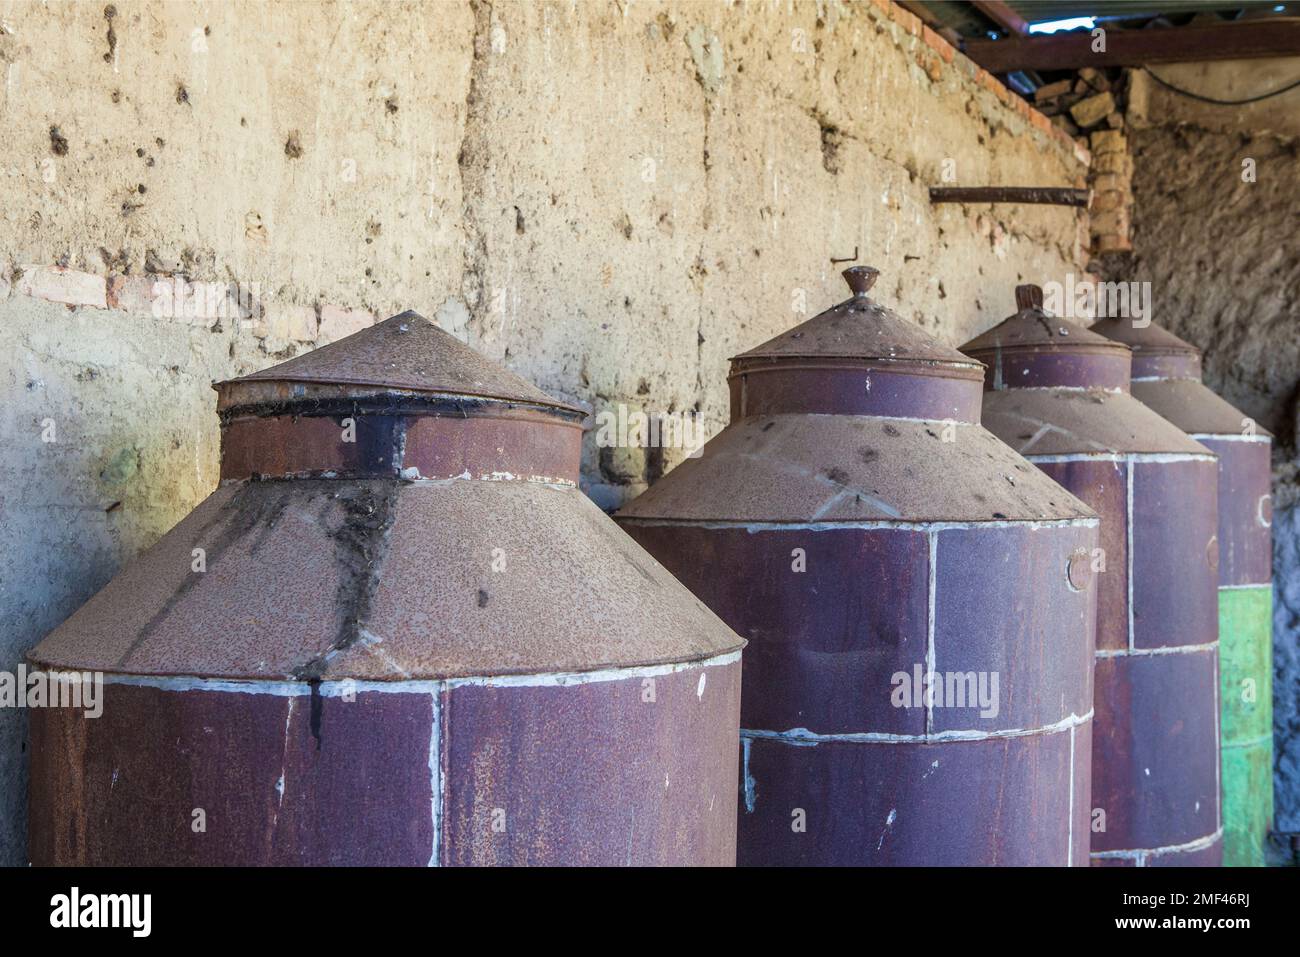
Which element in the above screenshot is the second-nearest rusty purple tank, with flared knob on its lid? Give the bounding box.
[618,267,1097,865]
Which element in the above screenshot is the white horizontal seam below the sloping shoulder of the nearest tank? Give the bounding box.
[65,651,740,698]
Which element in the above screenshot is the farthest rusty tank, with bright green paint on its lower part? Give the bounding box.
[1092,319,1273,866]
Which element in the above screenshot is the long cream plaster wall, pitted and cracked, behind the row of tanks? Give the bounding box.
[0,0,1087,863]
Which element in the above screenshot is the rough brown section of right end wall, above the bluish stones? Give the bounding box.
[1128,125,1300,443]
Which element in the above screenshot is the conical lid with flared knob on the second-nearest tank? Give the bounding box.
[732,265,979,372]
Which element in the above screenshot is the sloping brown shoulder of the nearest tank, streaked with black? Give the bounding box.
[31,480,741,681]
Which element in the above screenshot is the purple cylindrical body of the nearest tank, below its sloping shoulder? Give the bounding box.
[30,662,740,867]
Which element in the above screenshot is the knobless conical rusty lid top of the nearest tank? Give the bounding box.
[213,311,582,413]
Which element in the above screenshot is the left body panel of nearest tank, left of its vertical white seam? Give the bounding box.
[29,684,434,866]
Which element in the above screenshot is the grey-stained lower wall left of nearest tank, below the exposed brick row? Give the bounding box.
[0,296,229,865]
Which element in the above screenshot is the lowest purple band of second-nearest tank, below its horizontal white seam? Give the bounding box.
[737,723,1091,866]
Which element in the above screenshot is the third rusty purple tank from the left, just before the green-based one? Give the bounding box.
[962,286,1222,866]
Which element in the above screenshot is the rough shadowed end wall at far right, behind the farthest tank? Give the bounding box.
[1113,57,1300,847]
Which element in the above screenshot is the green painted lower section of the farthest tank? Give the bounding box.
[1219,585,1273,867]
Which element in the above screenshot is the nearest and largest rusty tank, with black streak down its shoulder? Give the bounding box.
[30,312,744,866]
